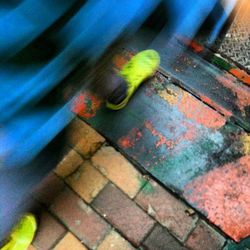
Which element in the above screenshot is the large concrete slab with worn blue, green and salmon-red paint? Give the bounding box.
[73,49,250,241]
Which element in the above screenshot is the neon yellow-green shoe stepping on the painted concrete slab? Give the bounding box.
[106,50,160,110]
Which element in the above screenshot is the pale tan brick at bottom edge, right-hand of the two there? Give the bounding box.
[97,230,134,250]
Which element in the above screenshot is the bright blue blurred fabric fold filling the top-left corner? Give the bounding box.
[0,0,76,61]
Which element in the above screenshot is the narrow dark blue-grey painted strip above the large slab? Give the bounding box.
[155,39,250,131]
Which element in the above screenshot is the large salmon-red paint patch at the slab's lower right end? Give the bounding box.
[184,156,250,241]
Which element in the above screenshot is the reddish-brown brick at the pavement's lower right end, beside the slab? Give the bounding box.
[186,221,225,250]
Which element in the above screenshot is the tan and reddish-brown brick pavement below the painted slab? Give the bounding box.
[29,118,247,250]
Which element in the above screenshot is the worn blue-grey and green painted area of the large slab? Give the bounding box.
[84,65,230,192]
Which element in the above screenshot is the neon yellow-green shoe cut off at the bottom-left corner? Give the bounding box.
[0,214,37,250]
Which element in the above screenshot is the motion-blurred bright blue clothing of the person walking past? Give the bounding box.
[0,0,159,167]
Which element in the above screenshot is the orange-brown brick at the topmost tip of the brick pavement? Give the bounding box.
[67,118,105,158]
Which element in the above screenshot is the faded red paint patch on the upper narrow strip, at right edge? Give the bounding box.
[216,73,250,111]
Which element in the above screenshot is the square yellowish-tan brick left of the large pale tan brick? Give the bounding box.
[67,161,108,203]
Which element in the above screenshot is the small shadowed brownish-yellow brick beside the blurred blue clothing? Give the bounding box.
[55,148,83,178]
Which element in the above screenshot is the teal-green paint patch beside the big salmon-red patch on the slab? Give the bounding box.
[149,131,224,192]
